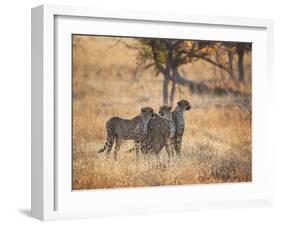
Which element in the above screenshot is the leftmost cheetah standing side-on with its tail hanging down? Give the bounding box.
[98,107,155,161]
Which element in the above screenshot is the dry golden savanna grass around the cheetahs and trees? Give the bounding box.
[72,36,252,190]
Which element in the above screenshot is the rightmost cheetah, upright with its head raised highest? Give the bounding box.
[172,100,191,155]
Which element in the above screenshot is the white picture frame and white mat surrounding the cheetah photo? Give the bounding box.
[31,5,273,220]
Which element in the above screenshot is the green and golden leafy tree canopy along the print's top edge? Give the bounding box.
[133,38,251,78]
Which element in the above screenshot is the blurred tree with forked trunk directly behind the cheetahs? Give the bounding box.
[137,38,229,106]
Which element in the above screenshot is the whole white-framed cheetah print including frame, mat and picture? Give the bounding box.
[32,5,273,220]
